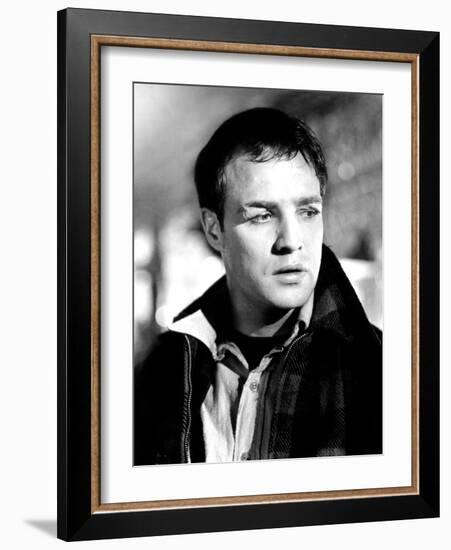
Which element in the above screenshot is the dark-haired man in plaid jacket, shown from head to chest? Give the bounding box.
[134,108,382,464]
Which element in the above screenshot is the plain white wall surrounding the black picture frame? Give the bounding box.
[0,0,451,550]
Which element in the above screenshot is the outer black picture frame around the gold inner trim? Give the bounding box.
[58,9,439,540]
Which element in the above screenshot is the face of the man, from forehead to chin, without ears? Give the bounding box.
[220,154,323,324]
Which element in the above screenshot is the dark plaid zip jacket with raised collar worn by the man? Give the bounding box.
[134,246,382,465]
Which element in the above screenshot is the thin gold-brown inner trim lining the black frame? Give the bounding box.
[91,35,420,514]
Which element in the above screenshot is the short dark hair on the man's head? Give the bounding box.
[194,108,327,224]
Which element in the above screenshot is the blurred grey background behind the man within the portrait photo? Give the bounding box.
[133,83,382,364]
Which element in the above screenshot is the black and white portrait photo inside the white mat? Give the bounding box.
[134,83,383,465]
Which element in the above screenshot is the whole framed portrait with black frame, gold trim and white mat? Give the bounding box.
[58,9,439,540]
